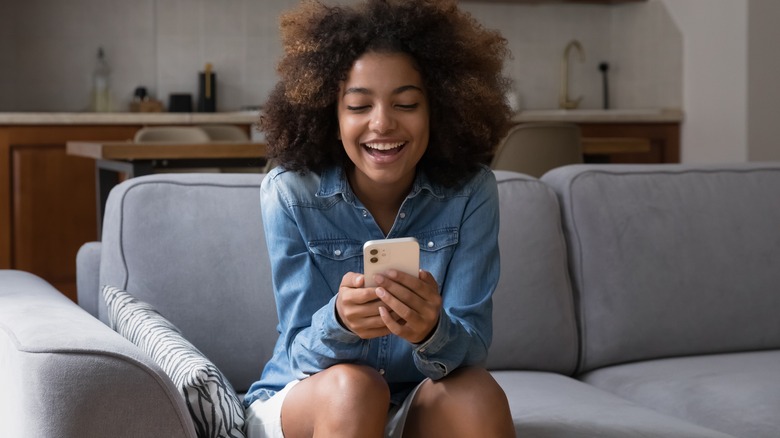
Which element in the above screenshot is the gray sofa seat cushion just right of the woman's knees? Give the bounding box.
[492,371,729,438]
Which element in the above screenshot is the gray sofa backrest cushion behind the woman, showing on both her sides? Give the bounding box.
[99,172,577,392]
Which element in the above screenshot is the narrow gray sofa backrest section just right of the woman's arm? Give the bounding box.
[487,171,578,374]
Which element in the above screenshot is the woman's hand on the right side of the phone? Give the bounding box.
[369,270,442,344]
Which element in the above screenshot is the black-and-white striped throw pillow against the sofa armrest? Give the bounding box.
[103,286,245,438]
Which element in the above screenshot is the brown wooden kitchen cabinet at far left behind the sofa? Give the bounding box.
[0,113,254,301]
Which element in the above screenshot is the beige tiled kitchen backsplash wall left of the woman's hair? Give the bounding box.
[0,0,298,111]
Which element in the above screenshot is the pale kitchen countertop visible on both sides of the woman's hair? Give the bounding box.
[0,108,683,125]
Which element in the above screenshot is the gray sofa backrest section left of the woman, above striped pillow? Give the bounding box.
[98,174,278,392]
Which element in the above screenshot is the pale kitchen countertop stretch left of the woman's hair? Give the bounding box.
[0,111,258,125]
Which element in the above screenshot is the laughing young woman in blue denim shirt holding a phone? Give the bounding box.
[245,0,514,438]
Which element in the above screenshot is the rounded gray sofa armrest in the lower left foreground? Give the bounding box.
[0,270,195,437]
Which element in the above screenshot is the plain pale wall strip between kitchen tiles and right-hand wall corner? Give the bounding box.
[663,0,748,163]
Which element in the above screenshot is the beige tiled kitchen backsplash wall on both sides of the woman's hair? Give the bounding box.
[0,0,682,111]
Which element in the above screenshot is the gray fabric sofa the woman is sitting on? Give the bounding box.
[0,163,780,438]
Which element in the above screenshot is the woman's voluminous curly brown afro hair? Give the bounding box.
[259,0,511,186]
